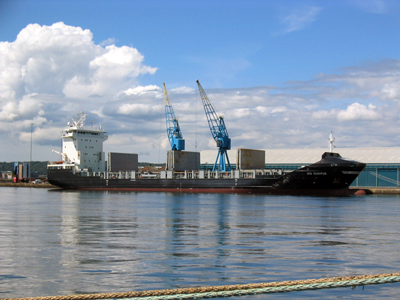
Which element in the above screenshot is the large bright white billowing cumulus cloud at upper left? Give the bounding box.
[0,22,157,103]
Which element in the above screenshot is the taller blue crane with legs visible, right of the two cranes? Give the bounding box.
[196,80,231,172]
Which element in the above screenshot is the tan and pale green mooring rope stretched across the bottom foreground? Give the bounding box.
[2,273,400,300]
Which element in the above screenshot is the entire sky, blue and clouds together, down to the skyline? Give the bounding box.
[0,0,400,161]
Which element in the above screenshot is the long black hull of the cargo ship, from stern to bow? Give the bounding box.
[47,153,365,195]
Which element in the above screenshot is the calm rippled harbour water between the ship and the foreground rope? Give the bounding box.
[0,188,400,299]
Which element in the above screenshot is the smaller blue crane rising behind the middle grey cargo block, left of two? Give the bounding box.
[163,82,185,151]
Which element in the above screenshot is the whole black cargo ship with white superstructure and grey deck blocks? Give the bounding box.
[47,113,366,195]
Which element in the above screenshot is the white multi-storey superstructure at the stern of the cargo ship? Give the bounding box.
[53,112,108,172]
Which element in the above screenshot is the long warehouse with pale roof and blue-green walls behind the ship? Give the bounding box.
[200,147,400,187]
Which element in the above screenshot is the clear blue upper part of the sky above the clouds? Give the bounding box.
[0,0,400,88]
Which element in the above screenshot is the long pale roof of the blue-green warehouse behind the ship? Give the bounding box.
[200,147,400,164]
